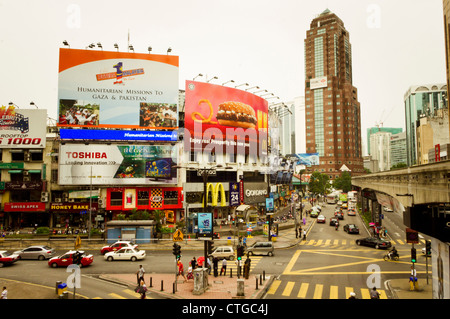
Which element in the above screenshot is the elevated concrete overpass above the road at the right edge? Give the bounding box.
[352,160,450,242]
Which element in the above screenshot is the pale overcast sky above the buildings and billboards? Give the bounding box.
[0,0,446,155]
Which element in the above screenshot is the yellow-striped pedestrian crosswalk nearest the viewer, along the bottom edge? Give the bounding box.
[267,280,388,299]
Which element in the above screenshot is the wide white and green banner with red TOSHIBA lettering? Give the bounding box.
[59,144,178,186]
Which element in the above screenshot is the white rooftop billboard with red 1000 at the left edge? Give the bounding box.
[0,105,47,149]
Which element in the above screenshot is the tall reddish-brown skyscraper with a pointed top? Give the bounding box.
[305,9,364,179]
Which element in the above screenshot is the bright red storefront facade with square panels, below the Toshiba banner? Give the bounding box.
[106,187,184,224]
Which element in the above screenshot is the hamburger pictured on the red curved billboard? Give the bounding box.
[216,102,257,128]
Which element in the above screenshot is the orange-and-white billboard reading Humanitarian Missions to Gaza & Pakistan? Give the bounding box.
[58,48,179,129]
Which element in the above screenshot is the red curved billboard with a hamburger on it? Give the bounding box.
[185,81,268,156]
